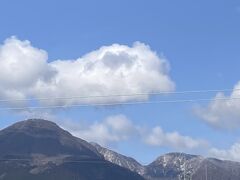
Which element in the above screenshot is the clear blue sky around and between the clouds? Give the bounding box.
[0,0,240,163]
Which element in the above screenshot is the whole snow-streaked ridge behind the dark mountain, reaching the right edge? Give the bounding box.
[94,144,240,180]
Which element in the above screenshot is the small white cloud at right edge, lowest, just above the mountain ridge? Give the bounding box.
[209,143,240,161]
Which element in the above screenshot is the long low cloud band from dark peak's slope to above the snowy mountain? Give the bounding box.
[55,115,208,150]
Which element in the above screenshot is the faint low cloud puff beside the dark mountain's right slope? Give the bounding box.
[59,115,137,145]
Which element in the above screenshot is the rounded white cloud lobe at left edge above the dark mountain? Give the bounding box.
[0,37,54,104]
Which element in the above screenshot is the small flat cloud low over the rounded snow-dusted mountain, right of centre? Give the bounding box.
[145,126,208,150]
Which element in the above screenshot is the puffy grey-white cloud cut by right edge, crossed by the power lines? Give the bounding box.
[195,82,240,130]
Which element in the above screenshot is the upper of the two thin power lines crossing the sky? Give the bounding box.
[0,89,240,102]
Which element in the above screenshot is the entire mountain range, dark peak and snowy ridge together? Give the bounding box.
[0,119,240,180]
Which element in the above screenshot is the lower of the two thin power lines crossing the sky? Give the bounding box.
[0,96,240,110]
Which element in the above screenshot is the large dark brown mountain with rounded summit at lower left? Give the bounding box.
[0,119,143,180]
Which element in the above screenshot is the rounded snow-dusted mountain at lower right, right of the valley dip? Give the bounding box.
[144,153,240,180]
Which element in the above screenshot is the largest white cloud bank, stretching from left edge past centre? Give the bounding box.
[0,37,174,105]
